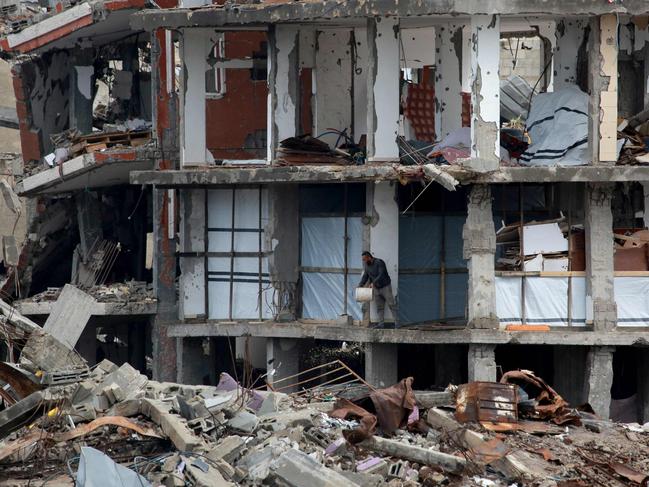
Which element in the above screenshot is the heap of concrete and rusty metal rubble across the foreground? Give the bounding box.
[0,303,649,487]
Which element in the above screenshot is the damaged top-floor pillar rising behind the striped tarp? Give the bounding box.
[552,19,585,91]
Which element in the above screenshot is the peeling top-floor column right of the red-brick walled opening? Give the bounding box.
[267,24,300,161]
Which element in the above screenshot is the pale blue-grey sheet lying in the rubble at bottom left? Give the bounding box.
[75,446,151,487]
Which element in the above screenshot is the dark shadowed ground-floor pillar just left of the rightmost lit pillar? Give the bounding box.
[551,345,588,406]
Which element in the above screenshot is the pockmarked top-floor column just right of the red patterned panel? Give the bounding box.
[435,23,463,140]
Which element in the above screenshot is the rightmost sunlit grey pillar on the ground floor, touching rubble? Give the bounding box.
[584,347,615,419]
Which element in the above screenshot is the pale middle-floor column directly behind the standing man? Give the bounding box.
[368,182,399,321]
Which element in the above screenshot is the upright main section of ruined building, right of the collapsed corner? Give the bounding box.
[121,0,649,420]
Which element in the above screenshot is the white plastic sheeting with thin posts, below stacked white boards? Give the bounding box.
[496,276,586,326]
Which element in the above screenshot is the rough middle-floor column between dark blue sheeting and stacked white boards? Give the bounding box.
[462,184,498,328]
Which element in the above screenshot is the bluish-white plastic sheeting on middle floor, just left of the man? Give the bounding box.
[301,216,363,320]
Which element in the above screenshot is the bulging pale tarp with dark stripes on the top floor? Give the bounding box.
[519,86,589,166]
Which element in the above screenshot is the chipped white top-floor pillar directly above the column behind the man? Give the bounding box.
[367,17,400,161]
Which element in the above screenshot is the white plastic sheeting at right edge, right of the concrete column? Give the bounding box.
[613,277,649,326]
